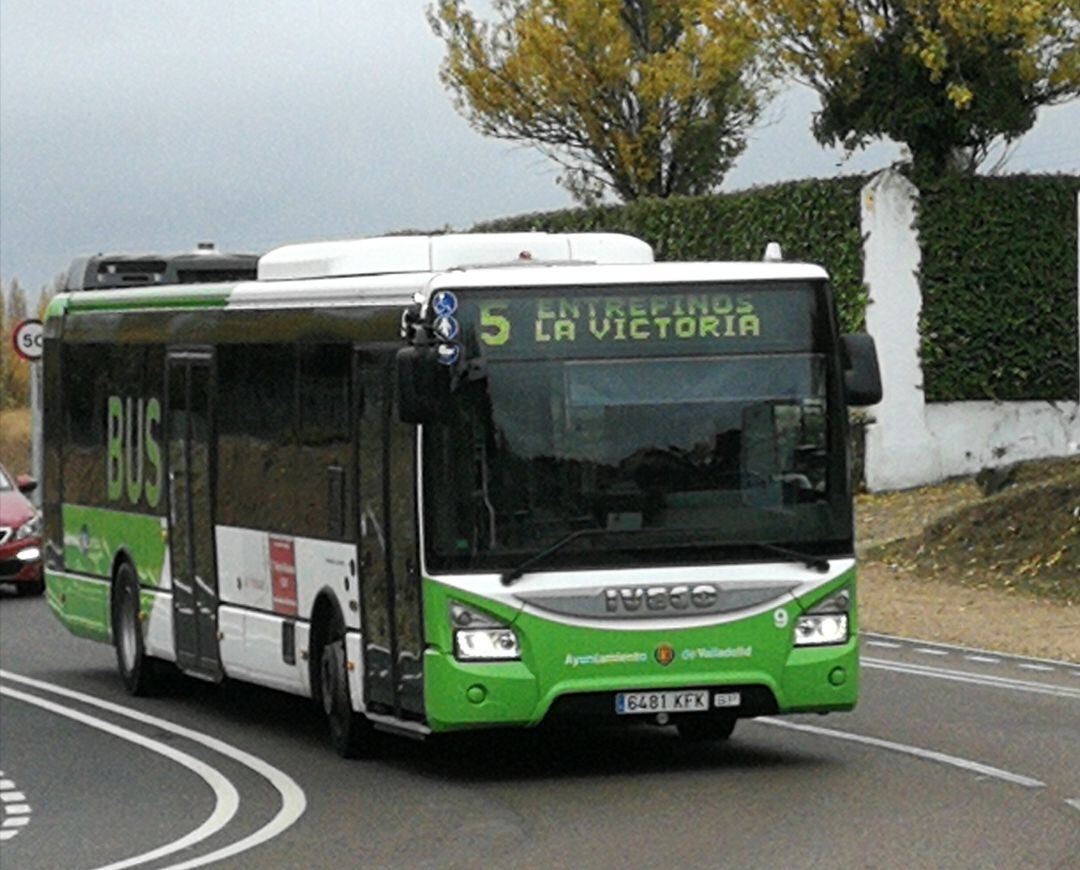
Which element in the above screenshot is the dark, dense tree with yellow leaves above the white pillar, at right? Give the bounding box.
[755,0,1080,178]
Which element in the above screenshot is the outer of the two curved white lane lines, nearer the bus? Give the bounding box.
[0,668,308,870]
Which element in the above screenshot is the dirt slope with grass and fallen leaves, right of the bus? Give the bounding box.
[856,458,1080,662]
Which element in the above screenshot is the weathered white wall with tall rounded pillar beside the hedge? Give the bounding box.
[862,169,1080,491]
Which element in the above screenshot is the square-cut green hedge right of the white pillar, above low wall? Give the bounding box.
[917,175,1080,402]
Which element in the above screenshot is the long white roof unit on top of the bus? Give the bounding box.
[258,232,652,281]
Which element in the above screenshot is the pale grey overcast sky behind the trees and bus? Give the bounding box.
[0,0,1080,300]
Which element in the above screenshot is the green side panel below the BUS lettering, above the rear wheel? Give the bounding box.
[63,504,168,586]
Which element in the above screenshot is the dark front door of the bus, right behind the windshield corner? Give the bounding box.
[353,351,423,717]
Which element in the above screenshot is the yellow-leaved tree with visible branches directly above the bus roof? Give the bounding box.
[428,0,767,203]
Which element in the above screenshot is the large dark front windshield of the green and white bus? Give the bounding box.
[423,285,850,571]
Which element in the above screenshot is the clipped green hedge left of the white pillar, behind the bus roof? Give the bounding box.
[474,176,866,331]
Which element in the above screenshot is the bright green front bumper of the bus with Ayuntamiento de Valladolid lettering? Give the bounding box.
[424,570,859,731]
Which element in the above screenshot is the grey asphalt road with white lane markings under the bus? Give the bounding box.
[0,589,1080,870]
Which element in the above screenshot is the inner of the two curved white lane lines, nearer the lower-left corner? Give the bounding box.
[0,687,240,870]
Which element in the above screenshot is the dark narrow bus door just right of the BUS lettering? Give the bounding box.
[166,350,222,680]
